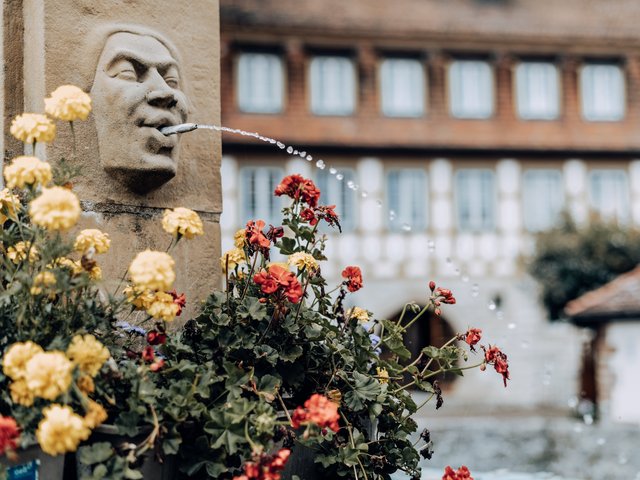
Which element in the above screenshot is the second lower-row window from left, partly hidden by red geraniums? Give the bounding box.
[316,169,357,232]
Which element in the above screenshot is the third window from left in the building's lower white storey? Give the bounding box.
[387,168,428,230]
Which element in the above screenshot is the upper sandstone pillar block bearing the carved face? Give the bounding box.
[24,0,221,212]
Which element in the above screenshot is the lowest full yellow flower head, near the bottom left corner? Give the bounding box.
[36,404,91,455]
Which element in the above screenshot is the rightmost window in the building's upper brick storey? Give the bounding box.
[580,64,625,121]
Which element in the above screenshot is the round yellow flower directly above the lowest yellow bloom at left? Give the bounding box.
[25,351,73,400]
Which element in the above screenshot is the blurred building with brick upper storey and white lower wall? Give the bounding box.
[221,0,640,410]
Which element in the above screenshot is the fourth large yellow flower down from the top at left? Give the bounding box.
[29,187,80,230]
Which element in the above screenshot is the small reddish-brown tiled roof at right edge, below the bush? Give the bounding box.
[564,266,640,323]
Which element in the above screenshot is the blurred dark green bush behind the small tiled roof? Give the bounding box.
[529,217,640,320]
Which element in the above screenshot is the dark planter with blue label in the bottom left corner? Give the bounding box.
[0,445,64,480]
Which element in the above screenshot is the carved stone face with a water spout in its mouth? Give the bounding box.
[91,32,188,193]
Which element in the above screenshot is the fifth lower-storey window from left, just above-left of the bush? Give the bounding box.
[523,170,564,232]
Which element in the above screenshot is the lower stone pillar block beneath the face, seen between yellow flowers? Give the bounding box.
[74,205,220,320]
